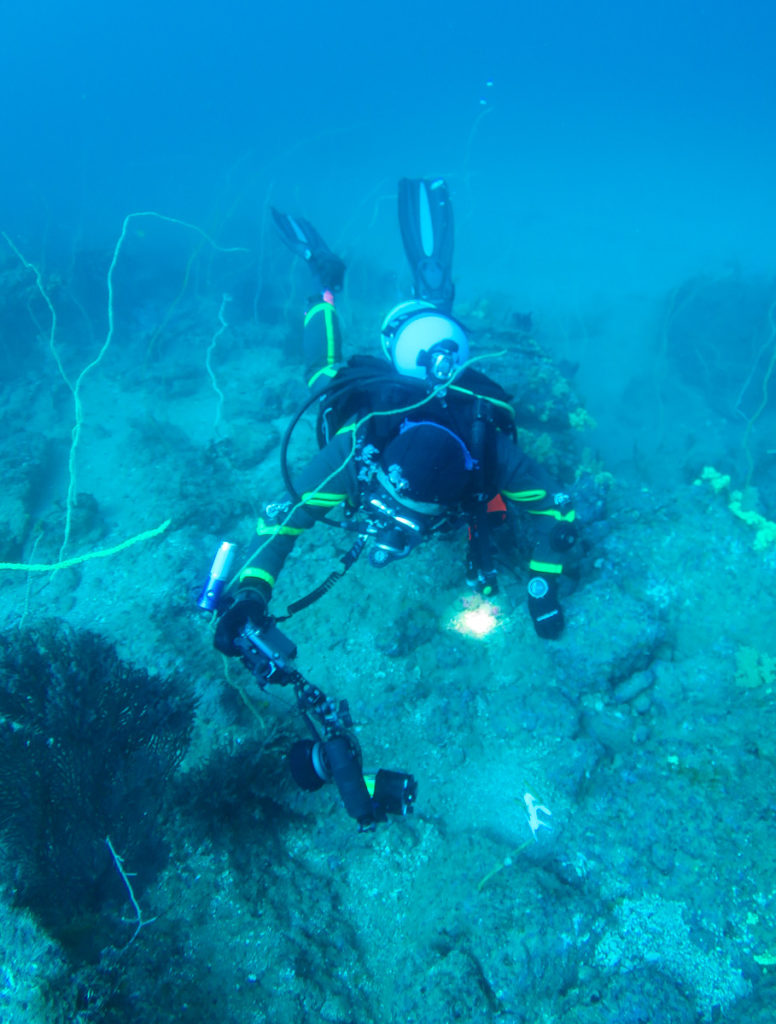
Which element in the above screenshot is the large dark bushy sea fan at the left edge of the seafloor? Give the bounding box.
[0,625,195,953]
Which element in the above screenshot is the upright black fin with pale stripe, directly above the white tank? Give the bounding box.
[398,178,456,313]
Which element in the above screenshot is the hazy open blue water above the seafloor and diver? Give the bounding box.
[0,0,776,354]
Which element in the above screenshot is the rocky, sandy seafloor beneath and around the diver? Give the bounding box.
[0,232,776,1024]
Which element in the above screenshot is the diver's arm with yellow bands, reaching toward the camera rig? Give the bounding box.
[240,430,358,601]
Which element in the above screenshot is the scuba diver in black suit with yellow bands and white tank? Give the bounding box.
[214,179,576,655]
